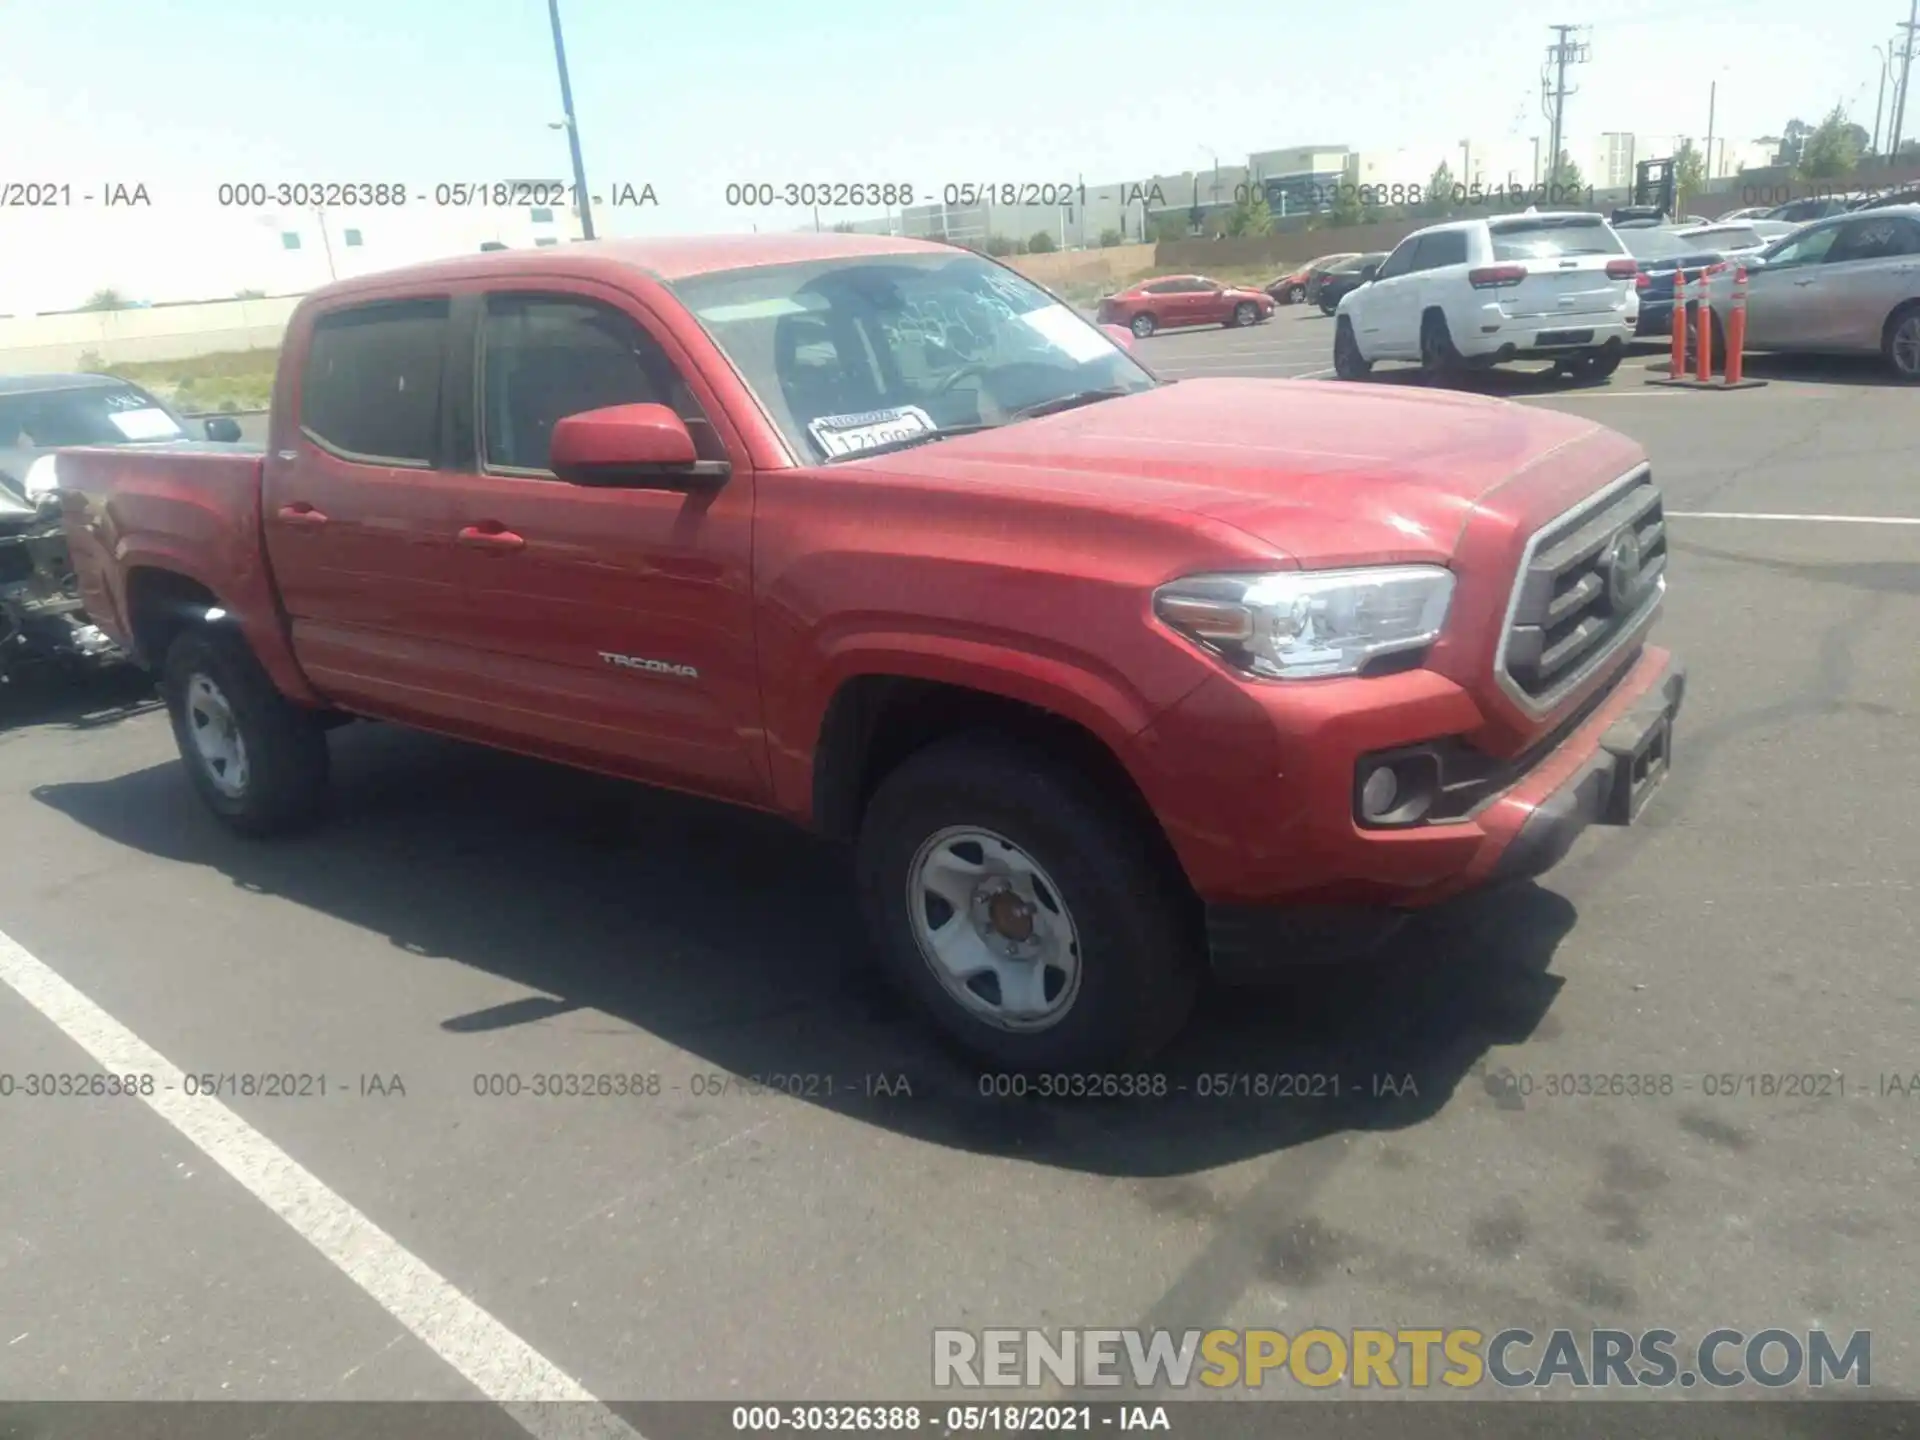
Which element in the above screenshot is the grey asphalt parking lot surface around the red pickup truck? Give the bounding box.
[0,309,1920,1434]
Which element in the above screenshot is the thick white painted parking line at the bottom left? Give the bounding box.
[0,931,641,1440]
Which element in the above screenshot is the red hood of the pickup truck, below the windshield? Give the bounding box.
[852,378,1605,566]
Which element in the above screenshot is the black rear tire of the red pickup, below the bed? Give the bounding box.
[161,628,328,835]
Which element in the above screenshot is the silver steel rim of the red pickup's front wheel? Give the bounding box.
[906,826,1081,1031]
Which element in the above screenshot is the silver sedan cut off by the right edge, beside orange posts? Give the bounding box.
[1709,205,1920,384]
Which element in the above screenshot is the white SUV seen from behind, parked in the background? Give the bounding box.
[1332,211,1640,380]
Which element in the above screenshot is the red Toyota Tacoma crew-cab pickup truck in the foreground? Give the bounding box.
[58,234,1684,1069]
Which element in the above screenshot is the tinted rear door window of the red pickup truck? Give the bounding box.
[300,300,447,467]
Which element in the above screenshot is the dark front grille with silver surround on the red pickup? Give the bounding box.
[1494,467,1667,710]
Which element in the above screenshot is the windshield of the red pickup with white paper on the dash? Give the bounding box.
[672,253,1158,461]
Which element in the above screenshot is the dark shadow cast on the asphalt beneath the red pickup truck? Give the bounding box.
[35,726,1574,1177]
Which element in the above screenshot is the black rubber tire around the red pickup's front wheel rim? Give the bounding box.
[856,735,1202,1071]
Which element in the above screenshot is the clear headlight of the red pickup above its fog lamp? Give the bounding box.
[1154,564,1453,680]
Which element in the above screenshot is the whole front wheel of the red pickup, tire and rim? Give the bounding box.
[858,737,1200,1071]
